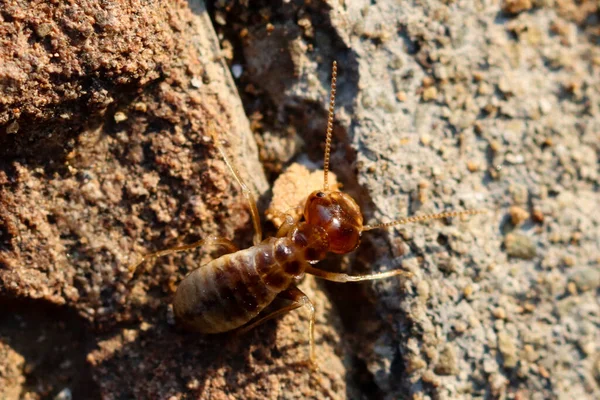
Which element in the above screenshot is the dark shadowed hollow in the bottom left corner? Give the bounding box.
[0,299,99,399]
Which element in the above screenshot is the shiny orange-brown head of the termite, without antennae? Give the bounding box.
[304,190,363,254]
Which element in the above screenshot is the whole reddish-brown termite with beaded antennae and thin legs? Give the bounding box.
[130,62,480,366]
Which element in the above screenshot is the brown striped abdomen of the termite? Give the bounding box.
[173,238,293,333]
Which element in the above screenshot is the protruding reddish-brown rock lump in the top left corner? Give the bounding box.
[0,1,183,156]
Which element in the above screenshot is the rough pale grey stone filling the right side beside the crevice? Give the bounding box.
[214,0,600,399]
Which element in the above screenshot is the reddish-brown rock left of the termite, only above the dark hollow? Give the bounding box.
[0,2,265,325]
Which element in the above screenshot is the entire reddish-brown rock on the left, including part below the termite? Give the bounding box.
[0,1,350,399]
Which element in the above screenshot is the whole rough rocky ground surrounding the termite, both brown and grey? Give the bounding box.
[0,0,600,399]
